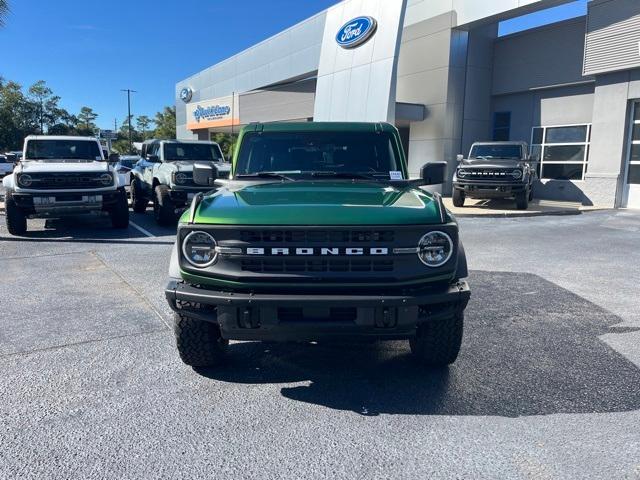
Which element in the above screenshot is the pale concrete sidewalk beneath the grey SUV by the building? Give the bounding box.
[444,198,607,217]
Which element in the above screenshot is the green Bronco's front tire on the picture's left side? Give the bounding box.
[173,313,229,367]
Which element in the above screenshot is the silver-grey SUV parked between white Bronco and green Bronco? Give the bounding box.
[131,140,231,225]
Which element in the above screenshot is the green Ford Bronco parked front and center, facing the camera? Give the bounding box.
[165,122,470,367]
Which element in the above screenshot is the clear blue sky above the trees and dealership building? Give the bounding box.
[0,0,586,129]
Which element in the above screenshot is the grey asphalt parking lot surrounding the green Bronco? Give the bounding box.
[0,199,640,479]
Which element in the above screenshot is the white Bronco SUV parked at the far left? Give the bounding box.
[2,135,129,235]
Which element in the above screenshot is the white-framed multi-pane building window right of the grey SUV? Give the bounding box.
[531,124,591,180]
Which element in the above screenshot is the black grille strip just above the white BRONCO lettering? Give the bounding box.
[240,230,395,245]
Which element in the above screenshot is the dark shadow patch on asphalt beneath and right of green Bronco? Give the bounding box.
[198,271,640,417]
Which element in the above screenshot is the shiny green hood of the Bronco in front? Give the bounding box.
[188,181,440,225]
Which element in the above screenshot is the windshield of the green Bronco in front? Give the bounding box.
[235,132,402,180]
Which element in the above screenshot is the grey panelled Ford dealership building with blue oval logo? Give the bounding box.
[175,0,640,208]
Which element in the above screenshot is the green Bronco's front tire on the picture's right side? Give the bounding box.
[409,312,464,367]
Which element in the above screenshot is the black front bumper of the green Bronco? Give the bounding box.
[165,281,470,341]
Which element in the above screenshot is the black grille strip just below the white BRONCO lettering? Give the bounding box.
[241,257,394,273]
